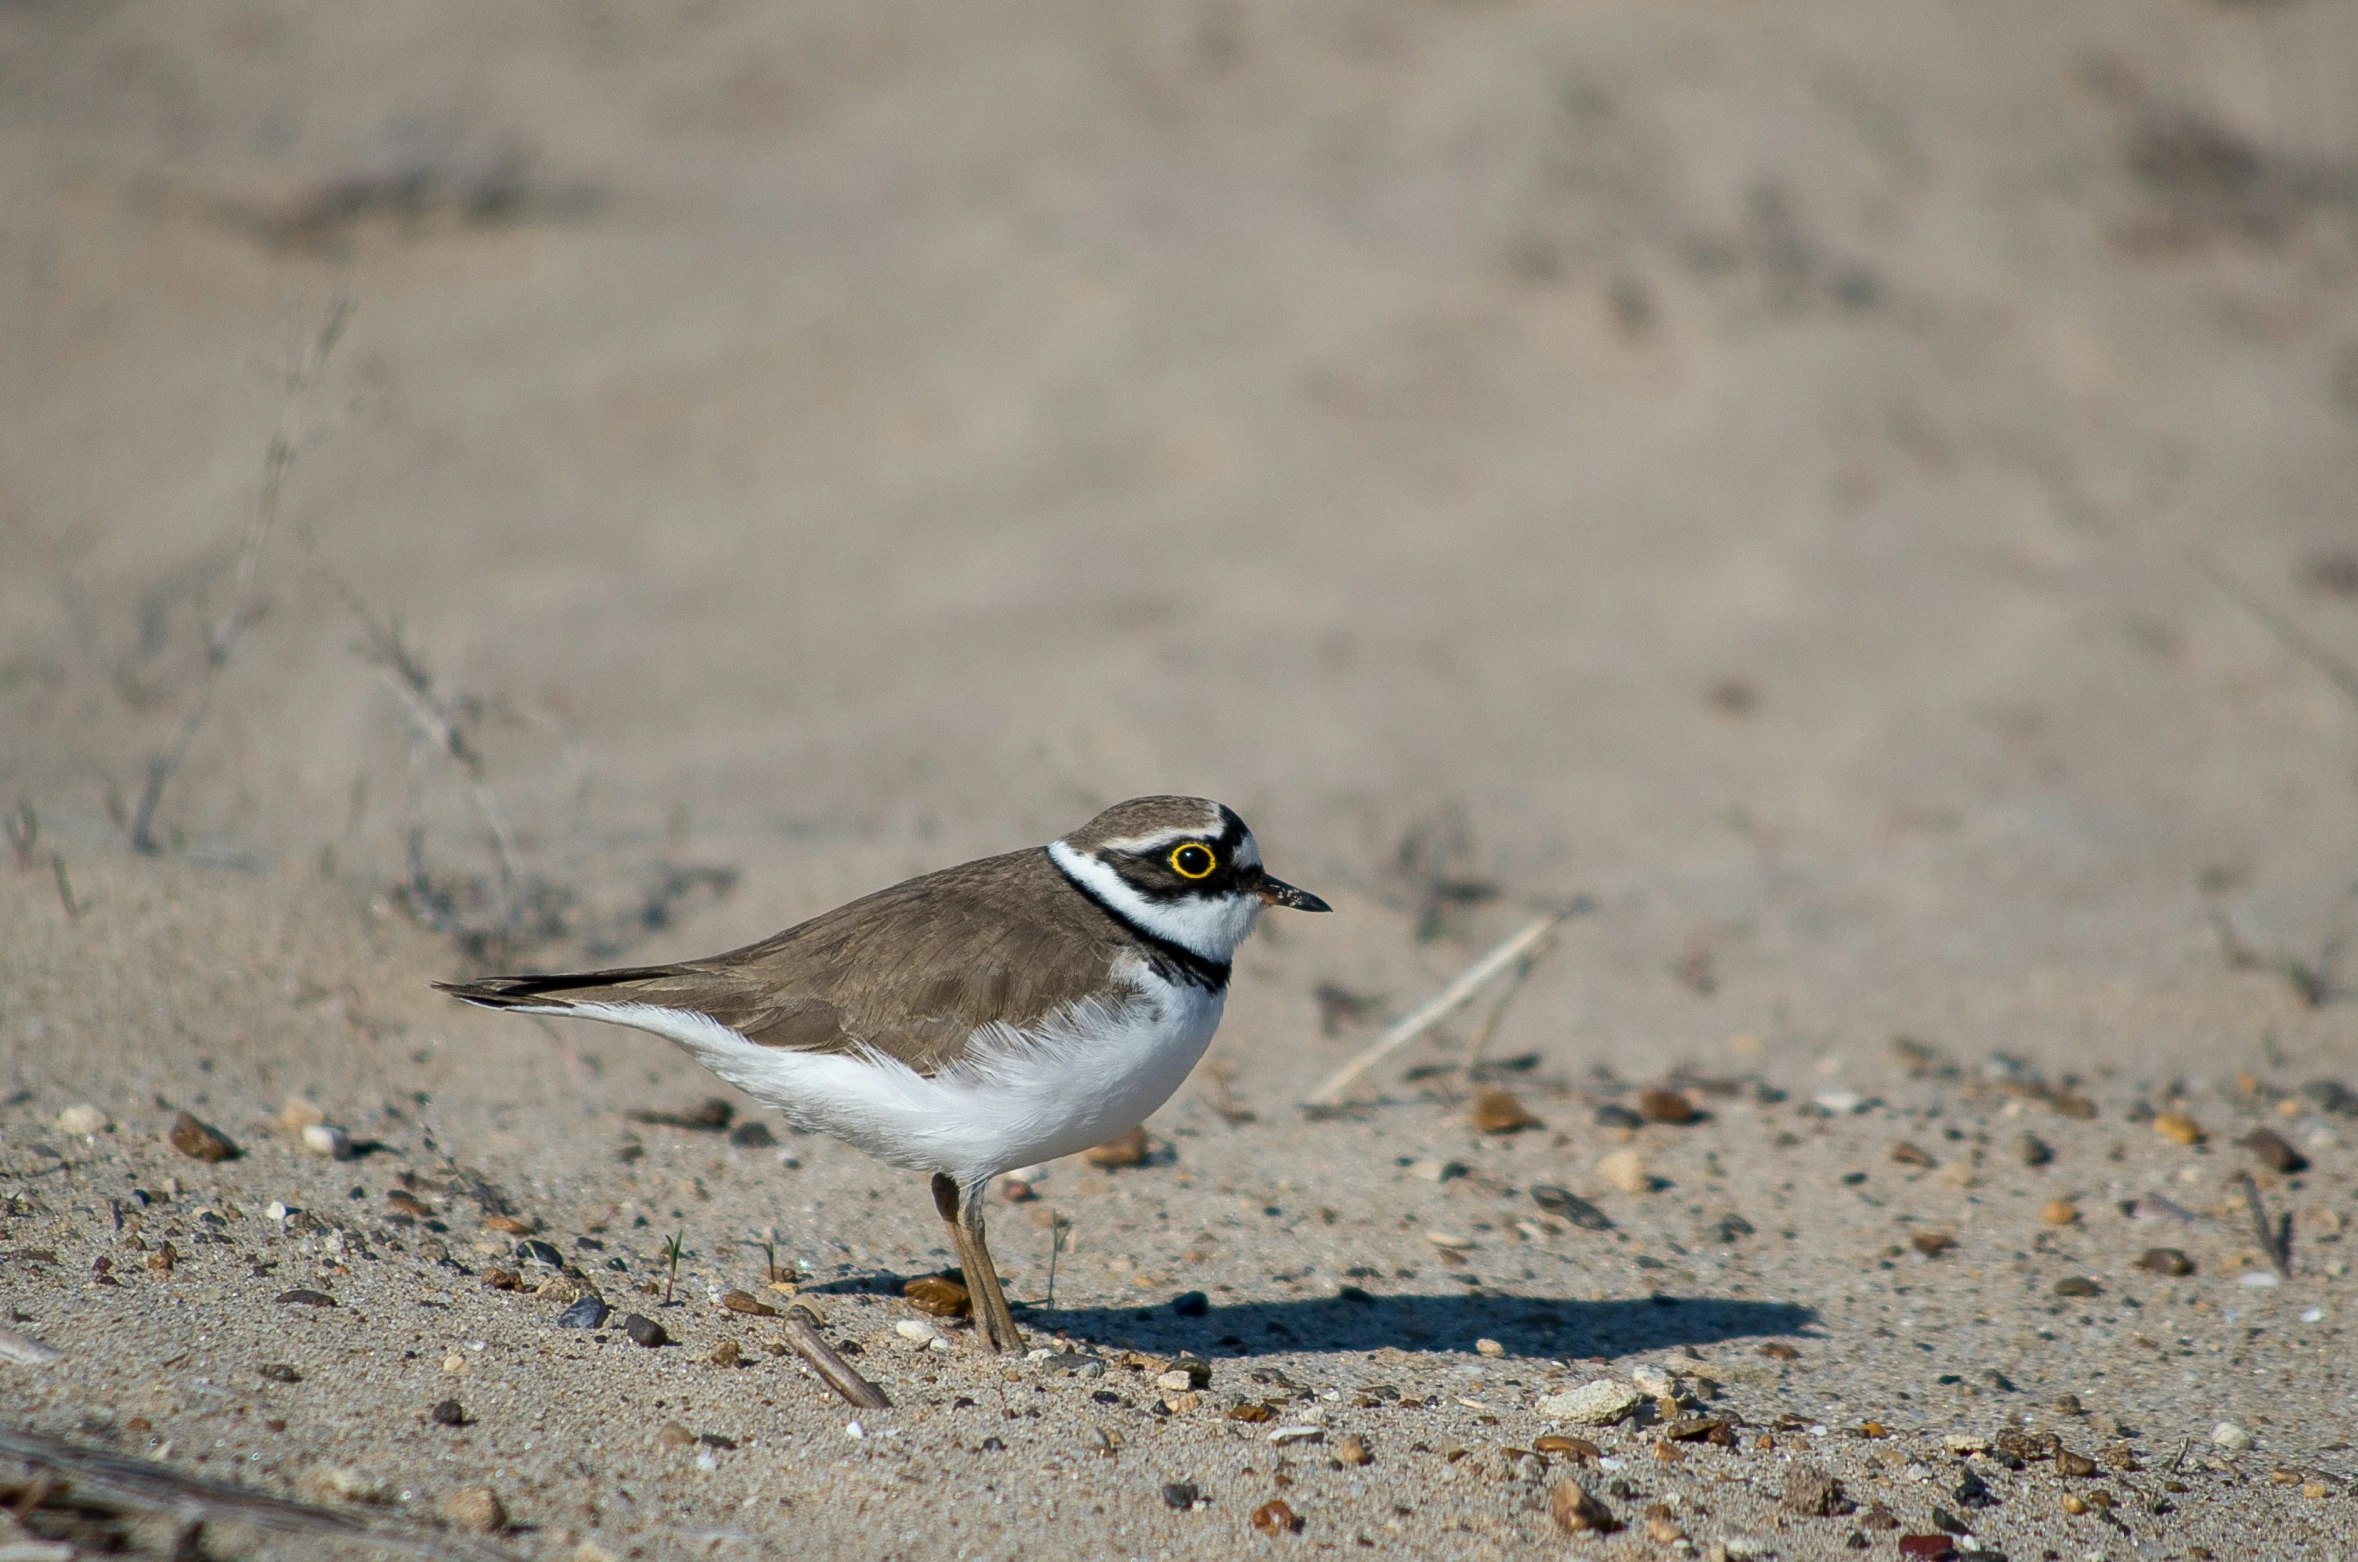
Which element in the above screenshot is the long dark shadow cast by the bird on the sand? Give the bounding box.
[1019,1293,1818,1357]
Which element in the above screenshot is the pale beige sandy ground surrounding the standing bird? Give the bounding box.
[0,0,2358,1560]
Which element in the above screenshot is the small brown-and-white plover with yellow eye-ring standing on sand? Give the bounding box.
[436,798,1328,1350]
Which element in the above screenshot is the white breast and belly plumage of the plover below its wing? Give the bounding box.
[545,960,1224,1187]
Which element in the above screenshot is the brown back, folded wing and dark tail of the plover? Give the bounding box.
[436,847,1129,1074]
